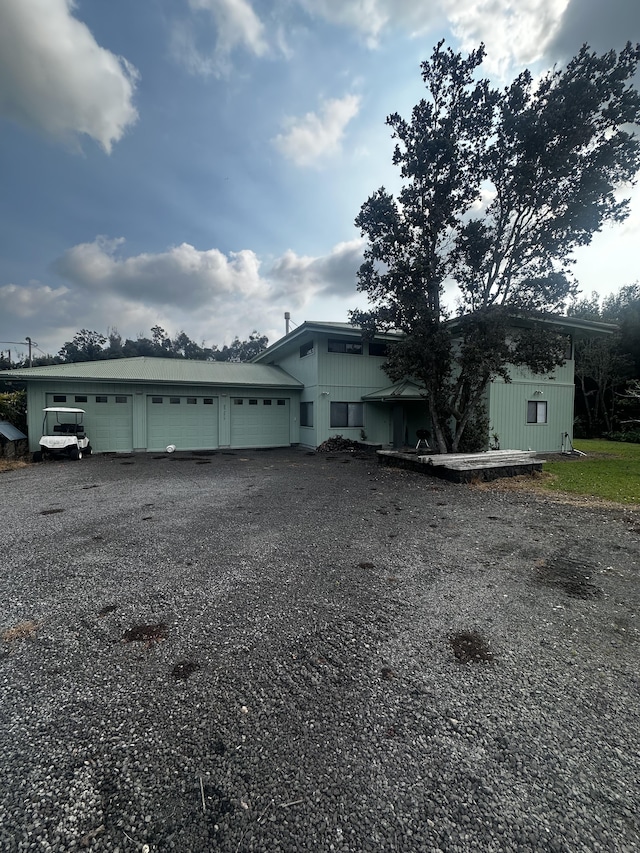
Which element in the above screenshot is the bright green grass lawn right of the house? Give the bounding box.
[543,439,640,504]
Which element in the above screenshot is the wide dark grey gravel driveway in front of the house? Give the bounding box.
[0,449,640,853]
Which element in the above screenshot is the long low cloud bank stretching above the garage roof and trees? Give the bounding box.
[0,237,363,353]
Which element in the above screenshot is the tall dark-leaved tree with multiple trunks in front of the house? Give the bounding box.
[351,42,640,452]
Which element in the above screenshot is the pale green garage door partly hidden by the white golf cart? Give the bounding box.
[47,394,133,453]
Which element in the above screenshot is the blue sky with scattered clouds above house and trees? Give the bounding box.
[0,0,640,357]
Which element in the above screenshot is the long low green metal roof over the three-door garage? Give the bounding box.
[0,356,303,388]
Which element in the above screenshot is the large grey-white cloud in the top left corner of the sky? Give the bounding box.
[0,0,138,152]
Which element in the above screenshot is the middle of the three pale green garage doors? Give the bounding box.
[147,394,219,450]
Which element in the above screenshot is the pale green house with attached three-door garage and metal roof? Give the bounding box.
[0,317,613,453]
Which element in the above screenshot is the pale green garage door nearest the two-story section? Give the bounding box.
[231,397,290,447]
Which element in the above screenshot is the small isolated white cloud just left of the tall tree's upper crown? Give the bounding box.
[273,95,360,166]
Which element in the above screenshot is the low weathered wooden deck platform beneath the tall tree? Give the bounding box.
[377,450,544,483]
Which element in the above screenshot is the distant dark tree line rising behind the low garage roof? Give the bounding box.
[0,326,269,370]
